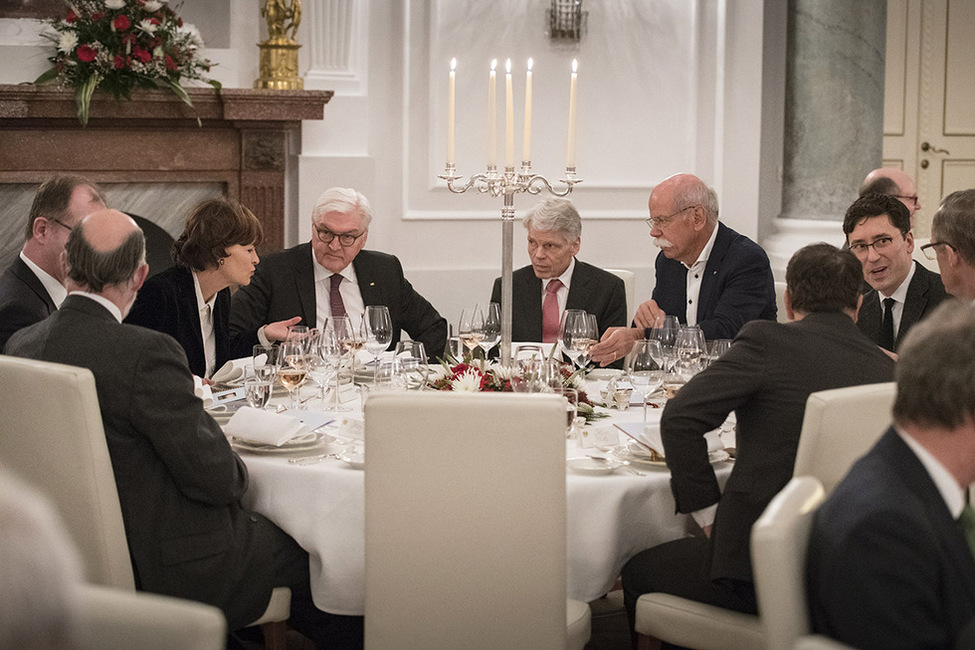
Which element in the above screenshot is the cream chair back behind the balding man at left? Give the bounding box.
[0,355,135,590]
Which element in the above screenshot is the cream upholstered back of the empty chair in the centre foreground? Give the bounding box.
[365,391,566,650]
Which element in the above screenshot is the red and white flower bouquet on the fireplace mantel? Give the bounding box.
[34,0,220,125]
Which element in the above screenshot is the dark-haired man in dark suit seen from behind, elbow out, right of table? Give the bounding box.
[623,244,894,623]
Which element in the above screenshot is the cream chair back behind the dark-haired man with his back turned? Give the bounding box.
[792,382,896,494]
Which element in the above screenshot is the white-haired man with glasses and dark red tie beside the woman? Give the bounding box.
[230,187,447,357]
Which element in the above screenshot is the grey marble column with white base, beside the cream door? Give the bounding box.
[766,0,887,277]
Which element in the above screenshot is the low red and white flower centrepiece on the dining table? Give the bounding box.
[427,356,609,422]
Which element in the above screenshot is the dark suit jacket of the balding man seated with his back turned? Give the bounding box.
[8,295,276,629]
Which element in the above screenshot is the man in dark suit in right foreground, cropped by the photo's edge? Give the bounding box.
[806,301,975,650]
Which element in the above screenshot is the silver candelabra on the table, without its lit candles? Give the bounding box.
[437,161,582,366]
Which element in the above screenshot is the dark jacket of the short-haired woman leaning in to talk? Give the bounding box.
[125,266,263,377]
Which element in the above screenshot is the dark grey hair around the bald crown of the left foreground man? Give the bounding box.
[64,223,146,293]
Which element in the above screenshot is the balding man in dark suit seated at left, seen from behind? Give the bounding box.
[8,210,361,647]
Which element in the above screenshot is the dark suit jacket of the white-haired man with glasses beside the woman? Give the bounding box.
[230,243,447,358]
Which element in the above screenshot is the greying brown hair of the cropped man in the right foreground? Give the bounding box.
[894,300,975,429]
